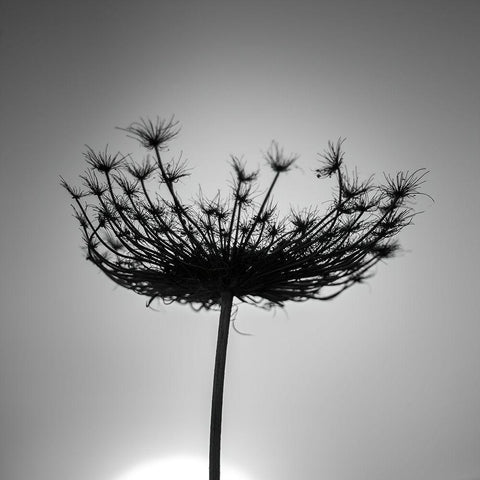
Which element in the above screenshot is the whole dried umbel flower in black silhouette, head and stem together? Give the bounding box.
[62,117,427,480]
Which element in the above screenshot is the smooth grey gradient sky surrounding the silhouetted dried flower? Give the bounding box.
[0,0,480,480]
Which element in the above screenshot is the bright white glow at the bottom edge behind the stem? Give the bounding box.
[115,457,250,480]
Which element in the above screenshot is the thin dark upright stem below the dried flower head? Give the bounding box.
[209,292,233,480]
